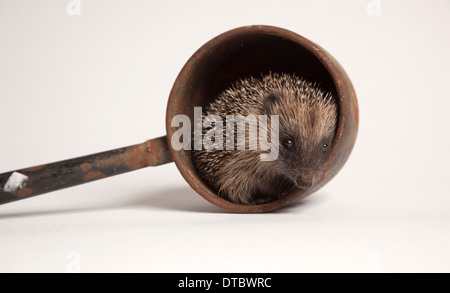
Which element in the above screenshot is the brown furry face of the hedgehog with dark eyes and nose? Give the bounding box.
[265,89,337,189]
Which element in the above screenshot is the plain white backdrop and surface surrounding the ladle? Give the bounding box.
[0,0,450,272]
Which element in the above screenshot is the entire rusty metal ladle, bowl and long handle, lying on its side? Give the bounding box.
[0,26,359,213]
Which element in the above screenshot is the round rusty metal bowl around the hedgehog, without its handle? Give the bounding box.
[166,26,359,213]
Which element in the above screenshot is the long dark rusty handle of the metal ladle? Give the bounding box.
[0,136,172,205]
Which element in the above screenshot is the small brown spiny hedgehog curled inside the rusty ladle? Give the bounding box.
[193,73,337,204]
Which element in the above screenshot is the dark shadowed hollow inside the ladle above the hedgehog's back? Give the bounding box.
[182,32,336,113]
